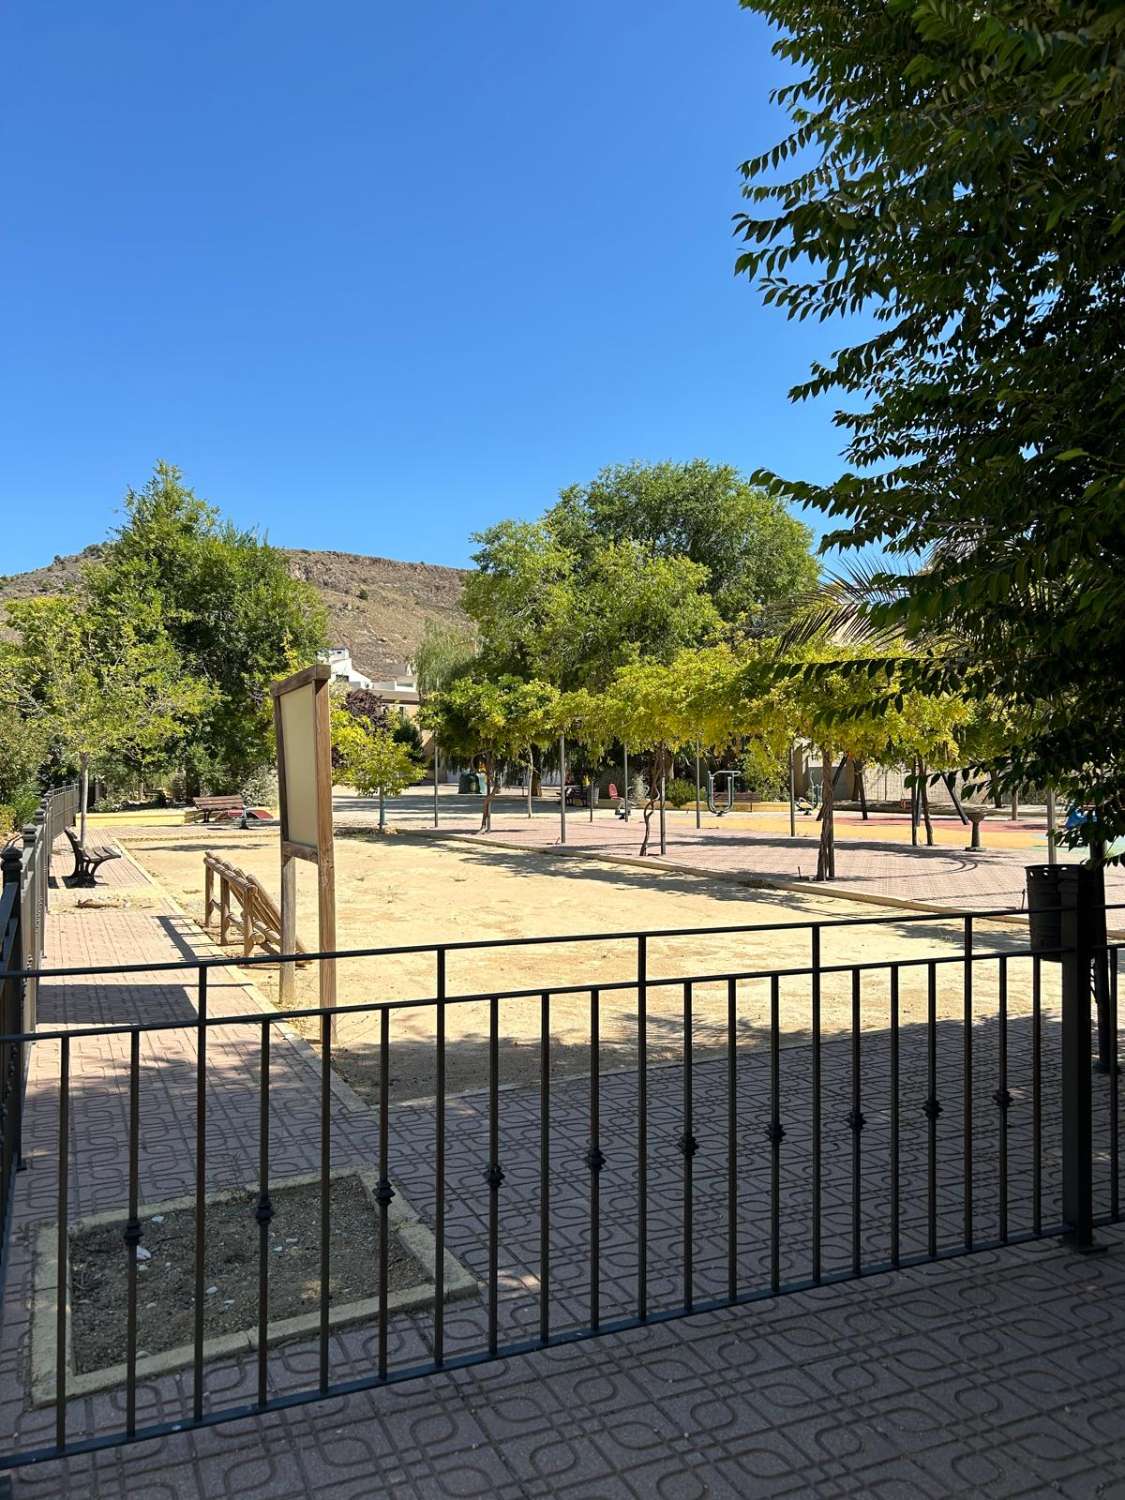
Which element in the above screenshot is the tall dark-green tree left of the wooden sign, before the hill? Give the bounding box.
[84,464,327,788]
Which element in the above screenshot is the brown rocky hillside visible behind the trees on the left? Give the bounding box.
[0,545,465,677]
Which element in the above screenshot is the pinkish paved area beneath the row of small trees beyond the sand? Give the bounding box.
[336,788,1125,908]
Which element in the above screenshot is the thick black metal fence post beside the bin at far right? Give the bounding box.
[1058,866,1095,1250]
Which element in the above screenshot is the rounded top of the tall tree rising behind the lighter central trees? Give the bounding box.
[546,459,819,624]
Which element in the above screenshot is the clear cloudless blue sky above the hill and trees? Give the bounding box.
[0,0,864,573]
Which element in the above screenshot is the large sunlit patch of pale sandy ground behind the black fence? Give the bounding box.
[123,828,1058,1100]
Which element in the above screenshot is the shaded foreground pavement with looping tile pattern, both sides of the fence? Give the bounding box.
[0,852,1125,1500]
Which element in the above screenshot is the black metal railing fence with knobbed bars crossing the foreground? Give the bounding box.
[0,891,1121,1467]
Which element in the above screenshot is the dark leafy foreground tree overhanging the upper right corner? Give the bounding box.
[738,0,1125,834]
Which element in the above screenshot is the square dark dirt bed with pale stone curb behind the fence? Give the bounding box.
[71,1176,431,1374]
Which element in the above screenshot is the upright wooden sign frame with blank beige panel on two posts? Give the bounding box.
[270,662,336,1008]
